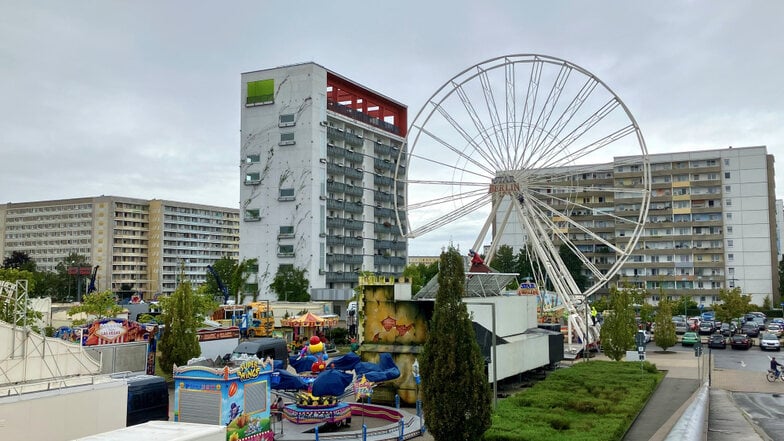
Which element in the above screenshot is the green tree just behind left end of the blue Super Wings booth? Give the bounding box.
[158,274,213,374]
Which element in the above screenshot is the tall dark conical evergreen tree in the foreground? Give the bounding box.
[421,247,490,441]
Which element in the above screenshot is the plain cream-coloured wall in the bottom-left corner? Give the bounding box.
[0,380,128,441]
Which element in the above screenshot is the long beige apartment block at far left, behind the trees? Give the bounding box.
[0,196,239,299]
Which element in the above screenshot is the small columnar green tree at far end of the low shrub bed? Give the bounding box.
[601,286,639,361]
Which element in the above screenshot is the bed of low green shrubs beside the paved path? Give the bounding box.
[484,361,664,441]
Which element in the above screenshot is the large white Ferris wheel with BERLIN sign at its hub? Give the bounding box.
[395,54,651,304]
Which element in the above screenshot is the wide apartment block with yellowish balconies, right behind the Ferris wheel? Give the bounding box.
[500,147,780,306]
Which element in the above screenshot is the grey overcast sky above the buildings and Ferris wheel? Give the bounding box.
[0,0,784,255]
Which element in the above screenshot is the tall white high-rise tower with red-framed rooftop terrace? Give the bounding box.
[240,63,407,306]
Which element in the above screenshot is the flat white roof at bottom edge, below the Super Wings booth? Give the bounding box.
[78,421,226,441]
